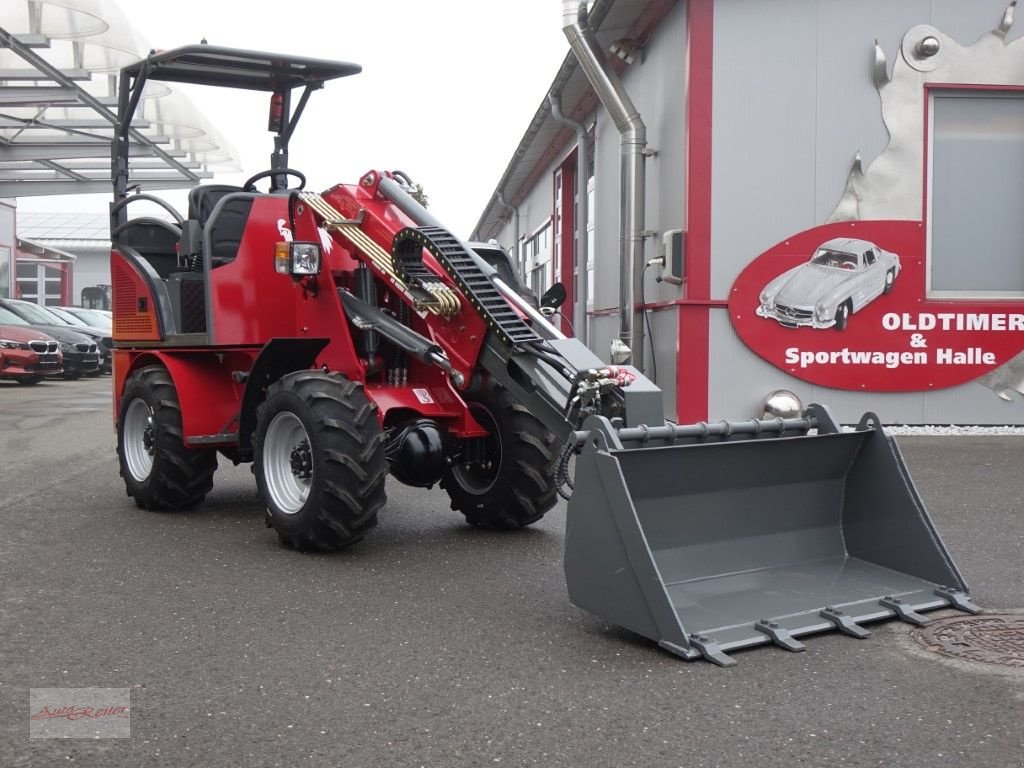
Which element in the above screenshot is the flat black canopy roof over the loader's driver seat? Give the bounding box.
[122,45,362,91]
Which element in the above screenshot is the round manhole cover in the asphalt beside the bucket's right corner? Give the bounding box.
[913,613,1024,669]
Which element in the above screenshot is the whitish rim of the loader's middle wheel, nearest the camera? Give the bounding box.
[263,411,312,515]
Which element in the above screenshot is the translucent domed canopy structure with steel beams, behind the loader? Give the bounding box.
[0,0,238,198]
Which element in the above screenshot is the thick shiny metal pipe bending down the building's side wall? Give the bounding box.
[562,0,647,371]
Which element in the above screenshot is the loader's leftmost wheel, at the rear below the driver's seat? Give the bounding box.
[118,366,217,511]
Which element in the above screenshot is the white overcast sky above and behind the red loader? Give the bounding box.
[18,0,568,237]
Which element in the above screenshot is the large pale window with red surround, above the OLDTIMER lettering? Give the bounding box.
[928,90,1024,299]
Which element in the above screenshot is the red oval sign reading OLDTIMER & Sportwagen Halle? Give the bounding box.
[729,221,1024,392]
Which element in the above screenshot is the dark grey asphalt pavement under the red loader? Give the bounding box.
[0,377,1024,768]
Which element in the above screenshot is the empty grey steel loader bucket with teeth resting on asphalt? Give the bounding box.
[565,406,978,666]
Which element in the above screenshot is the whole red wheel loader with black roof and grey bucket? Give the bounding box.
[111,45,976,665]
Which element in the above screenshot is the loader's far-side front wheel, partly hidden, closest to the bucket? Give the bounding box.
[440,384,558,530]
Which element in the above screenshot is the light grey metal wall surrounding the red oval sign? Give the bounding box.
[709,0,1024,424]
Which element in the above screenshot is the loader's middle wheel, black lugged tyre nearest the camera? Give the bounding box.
[253,371,388,552]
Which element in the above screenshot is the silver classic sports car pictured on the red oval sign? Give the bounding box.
[757,238,900,331]
